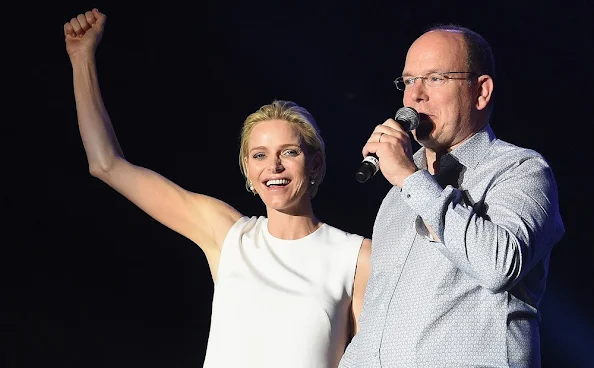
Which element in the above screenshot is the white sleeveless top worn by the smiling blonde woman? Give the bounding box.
[204,217,364,368]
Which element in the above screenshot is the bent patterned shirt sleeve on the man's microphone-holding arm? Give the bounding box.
[401,156,564,292]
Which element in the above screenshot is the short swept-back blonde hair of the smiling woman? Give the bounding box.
[239,100,326,198]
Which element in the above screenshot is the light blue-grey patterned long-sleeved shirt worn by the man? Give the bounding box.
[340,126,565,368]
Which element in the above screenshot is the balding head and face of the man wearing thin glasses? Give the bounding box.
[402,28,493,152]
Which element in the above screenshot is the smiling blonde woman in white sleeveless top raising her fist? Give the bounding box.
[64,9,371,368]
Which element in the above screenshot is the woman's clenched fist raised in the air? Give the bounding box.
[64,9,107,59]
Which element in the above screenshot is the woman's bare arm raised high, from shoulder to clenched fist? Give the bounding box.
[64,9,241,276]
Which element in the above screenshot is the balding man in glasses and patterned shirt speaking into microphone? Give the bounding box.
[340,26,565,368]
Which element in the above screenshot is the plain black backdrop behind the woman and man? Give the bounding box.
[5,0,594,368]
